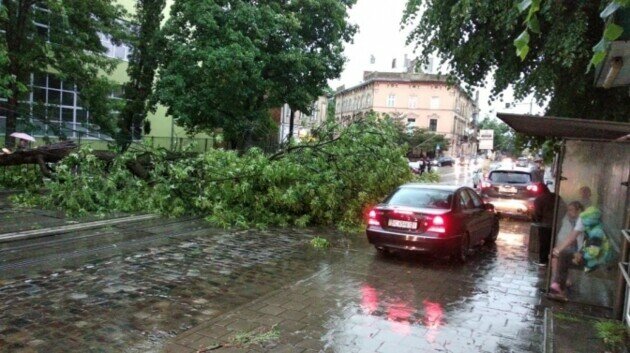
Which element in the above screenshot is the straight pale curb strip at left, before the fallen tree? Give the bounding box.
[0,214,159,243]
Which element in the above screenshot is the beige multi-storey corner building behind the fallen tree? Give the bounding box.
[335,72,478,156]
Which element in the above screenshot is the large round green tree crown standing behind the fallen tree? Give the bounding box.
[156,0,355,147]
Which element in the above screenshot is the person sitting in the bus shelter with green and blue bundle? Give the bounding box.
[550,207,613,300]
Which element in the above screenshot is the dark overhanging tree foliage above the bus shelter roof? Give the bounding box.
[403,0,630,121]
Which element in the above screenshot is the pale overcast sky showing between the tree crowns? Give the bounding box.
[330,0,543,118]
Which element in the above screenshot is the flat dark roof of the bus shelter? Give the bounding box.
[497,113,630,141]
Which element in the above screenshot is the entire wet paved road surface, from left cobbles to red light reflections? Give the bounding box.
[0,167,542,353]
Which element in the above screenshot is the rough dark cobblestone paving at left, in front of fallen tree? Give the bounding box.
[0,220,336,353]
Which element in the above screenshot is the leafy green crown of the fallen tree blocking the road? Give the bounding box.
[14,118,412,229]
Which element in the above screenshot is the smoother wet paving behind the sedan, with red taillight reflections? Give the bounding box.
[169,220,543,353]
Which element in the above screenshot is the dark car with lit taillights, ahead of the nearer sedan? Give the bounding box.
[480,167,543,218]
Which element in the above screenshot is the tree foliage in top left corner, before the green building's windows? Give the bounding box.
[0,0,125,146]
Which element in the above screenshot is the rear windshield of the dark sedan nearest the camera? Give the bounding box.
[384,188,453,210]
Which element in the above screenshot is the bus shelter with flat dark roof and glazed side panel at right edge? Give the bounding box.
[498,114,630,323]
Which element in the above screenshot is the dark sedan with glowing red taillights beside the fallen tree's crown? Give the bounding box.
[366,184,499,261]
